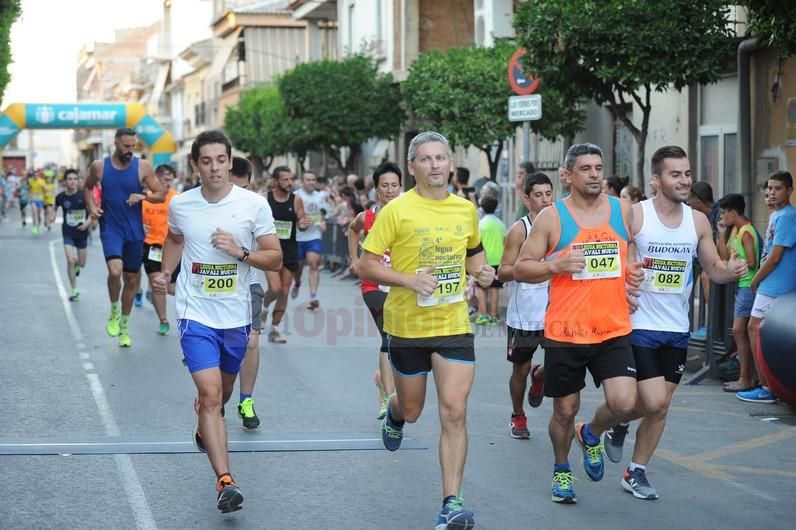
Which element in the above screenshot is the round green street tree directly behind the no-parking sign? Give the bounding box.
[402,42,583,179]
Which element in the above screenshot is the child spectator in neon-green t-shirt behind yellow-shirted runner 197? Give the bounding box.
[475,194,506,326]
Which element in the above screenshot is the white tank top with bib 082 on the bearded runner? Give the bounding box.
[631,199,698,333]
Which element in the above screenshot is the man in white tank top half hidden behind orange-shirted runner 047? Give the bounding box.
[498,173,553,440]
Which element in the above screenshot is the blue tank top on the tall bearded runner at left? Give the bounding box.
[100,156,144,241]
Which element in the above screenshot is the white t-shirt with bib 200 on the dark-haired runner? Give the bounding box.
[169,186,276,329]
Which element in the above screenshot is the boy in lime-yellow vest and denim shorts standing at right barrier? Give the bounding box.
[718,193,760,392]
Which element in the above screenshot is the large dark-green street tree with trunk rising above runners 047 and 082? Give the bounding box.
[514,0,732,186]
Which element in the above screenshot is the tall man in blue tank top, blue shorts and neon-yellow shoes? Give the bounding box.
[83,127,167,346]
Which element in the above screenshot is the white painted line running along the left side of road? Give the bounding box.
[50,239,157,530]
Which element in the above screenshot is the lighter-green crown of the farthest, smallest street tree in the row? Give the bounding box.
[224,87,294,167]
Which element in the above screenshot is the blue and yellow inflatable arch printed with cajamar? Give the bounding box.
[0,103,177,166]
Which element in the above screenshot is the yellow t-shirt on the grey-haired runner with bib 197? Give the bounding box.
[362,189,481,338]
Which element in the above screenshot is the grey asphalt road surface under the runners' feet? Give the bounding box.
[0,212,796,529]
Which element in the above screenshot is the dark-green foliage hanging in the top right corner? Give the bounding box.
[742,0,796,57]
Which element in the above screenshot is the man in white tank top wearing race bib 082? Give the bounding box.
[604,146,747,499]
